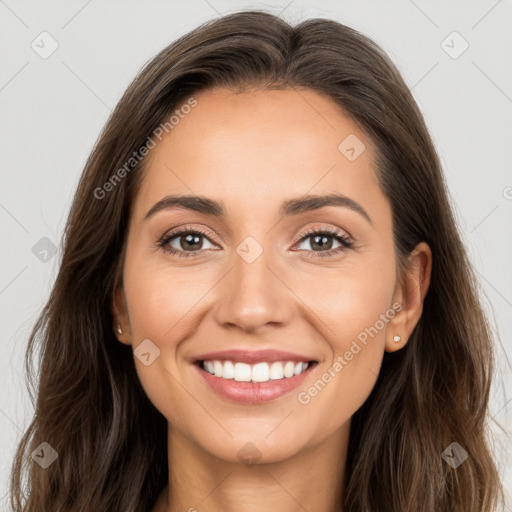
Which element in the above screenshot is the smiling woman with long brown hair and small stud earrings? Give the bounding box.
[11,11,502,512]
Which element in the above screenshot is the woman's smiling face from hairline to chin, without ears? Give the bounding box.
[115,89,410,462]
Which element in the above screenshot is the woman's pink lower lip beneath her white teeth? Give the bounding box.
[194,363,317,404]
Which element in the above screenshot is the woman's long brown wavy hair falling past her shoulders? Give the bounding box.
[11,11,503,512]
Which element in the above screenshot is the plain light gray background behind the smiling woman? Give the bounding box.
[0,0,512,510]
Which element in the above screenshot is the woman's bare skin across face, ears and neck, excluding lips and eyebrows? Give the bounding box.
[113,88,432,512]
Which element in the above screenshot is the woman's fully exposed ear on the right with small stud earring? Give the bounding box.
[385,242,432,352]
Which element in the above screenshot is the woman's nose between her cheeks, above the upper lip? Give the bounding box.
[211,246,295,332]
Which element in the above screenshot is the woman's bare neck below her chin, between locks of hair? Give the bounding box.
[153,422,350,512]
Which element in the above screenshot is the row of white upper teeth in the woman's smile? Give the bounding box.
[202,360,309,382]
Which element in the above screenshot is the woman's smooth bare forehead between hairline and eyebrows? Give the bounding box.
[135,88,380,218]
